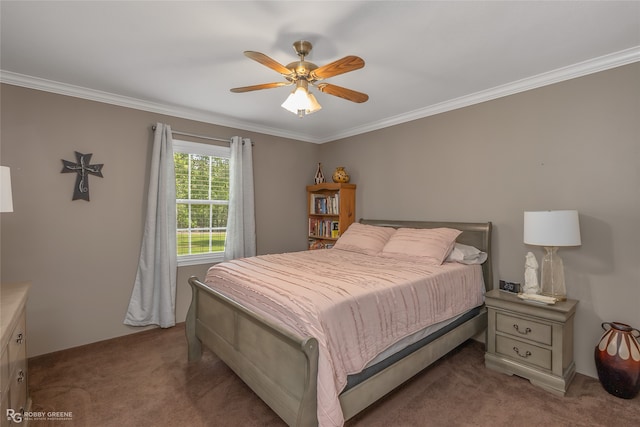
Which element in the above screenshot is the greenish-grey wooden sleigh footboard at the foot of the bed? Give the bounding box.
[186,277,318,426]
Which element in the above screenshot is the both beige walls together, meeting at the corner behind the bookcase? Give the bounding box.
[0,64,640,376]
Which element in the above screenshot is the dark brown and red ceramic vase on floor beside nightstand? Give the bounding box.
[595,322,640,399]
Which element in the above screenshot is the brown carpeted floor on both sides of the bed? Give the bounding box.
[29,324,640,427]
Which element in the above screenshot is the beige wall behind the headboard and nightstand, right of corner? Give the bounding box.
[322,63,640,376]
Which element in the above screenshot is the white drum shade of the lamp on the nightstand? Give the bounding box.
[524,210,582,246]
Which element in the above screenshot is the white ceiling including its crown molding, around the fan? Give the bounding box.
[0,0,640,143]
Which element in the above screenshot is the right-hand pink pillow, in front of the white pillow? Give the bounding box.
[381,228,462,265]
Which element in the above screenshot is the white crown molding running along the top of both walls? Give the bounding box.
[0,46,640,144]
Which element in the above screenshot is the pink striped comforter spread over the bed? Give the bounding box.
[205,249,484,426]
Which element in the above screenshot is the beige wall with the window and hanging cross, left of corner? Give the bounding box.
[0,85,319,356]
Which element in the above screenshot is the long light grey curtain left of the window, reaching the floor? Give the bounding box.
[124,123,177,328]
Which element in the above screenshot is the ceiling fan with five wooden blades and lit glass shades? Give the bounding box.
[231,40,369,117]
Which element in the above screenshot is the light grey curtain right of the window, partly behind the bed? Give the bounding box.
[224,136,256,260]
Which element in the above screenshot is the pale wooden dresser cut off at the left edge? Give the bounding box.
[0,283,31,427]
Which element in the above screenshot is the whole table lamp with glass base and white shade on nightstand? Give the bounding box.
[524,210,582,301]
